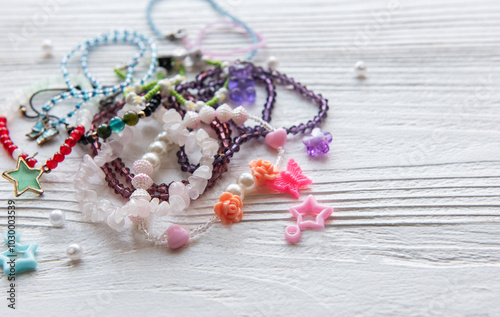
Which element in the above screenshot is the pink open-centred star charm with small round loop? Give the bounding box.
[285,195,333,243]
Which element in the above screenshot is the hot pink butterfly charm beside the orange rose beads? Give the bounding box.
[267,159,312,199]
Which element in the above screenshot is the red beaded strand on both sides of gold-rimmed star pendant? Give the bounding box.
[0,116,85,171]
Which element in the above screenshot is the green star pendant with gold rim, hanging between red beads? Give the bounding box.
[2,157,44,197]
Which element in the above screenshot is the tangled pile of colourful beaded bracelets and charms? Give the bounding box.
[0,0,333,274]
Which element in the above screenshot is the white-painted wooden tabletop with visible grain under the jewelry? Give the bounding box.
[0,0,500,316]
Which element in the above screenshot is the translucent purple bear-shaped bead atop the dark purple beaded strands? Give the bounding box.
[228,63,256,106]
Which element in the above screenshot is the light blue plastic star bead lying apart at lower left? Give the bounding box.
[0,232,38,276]
